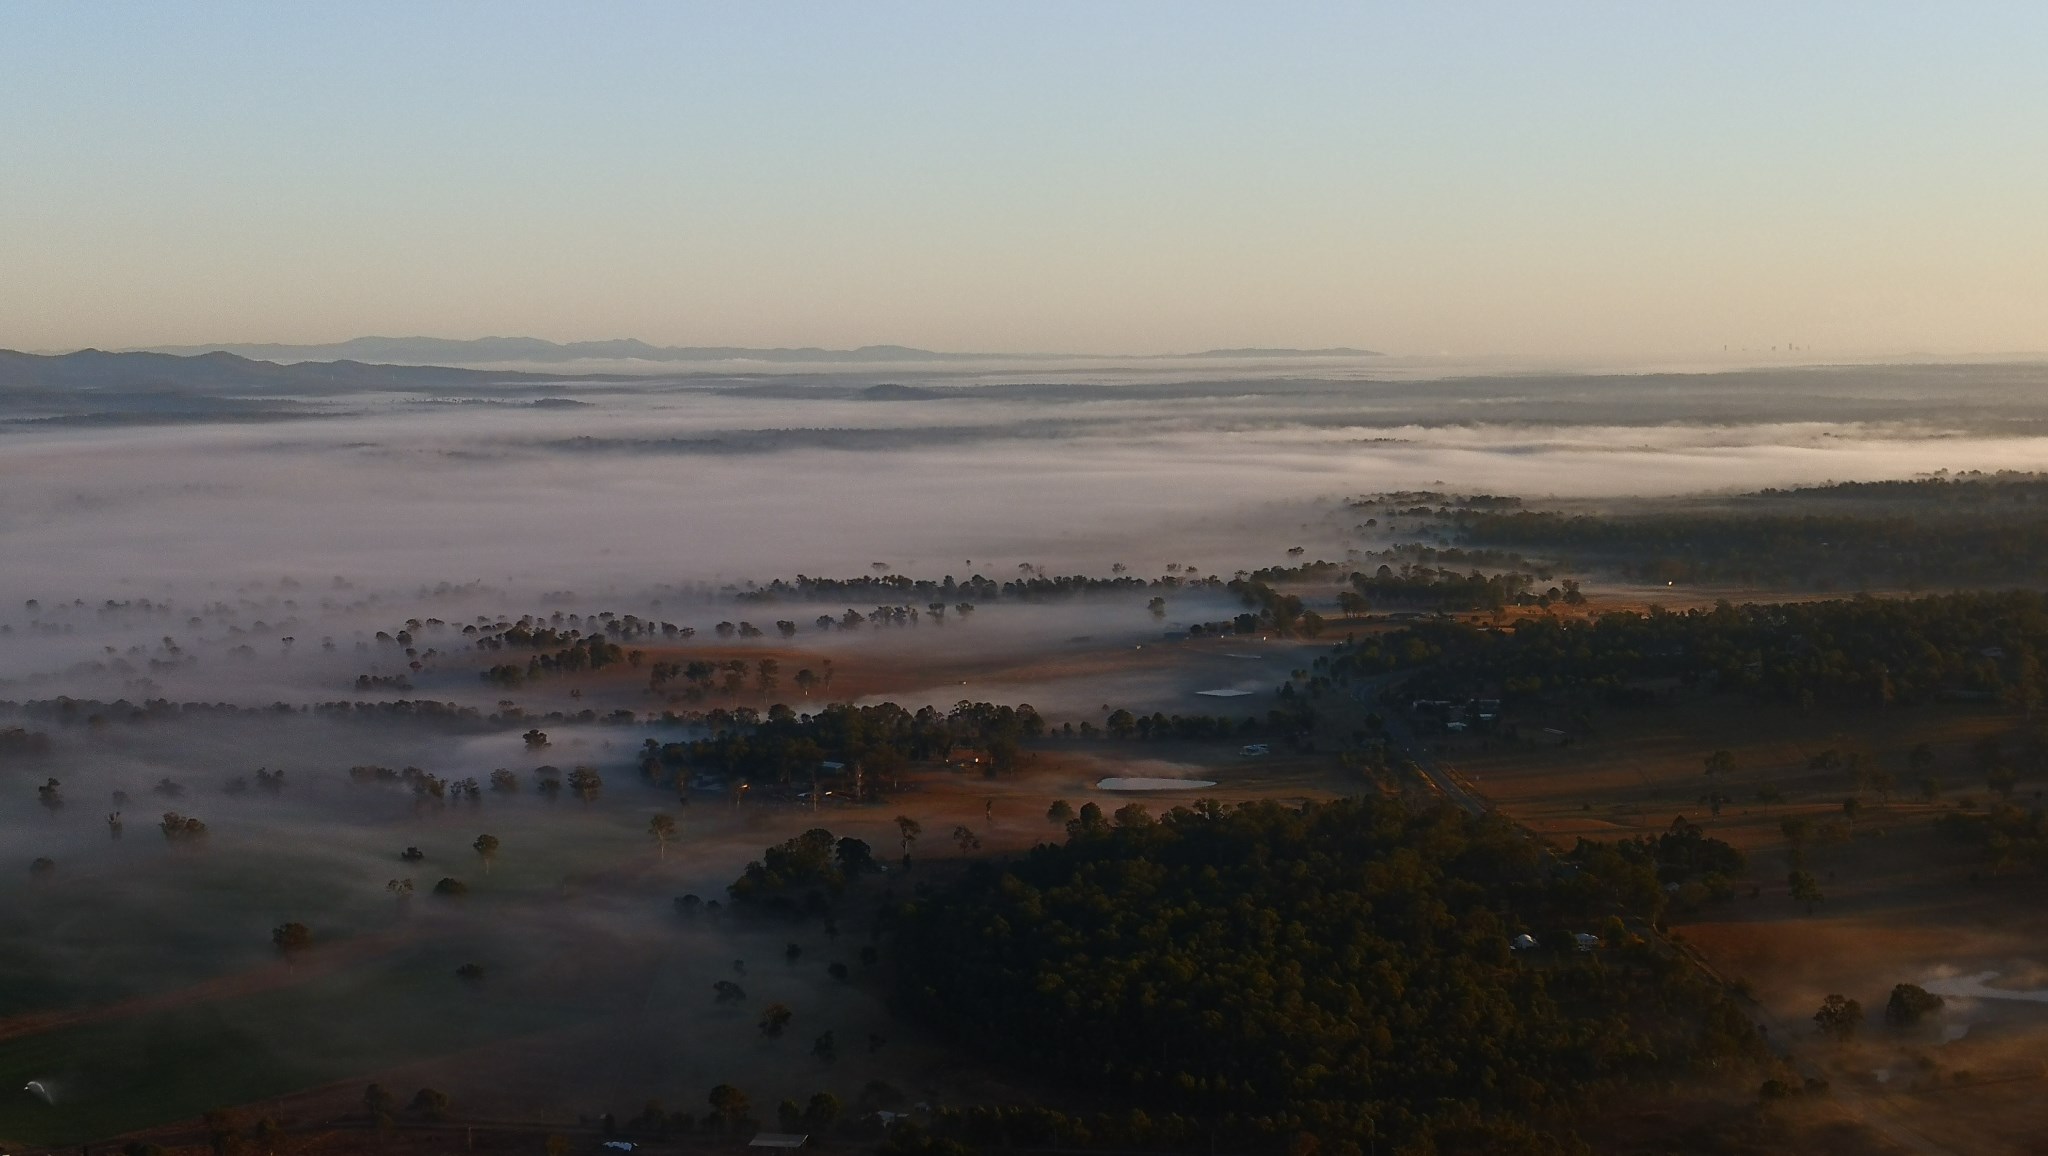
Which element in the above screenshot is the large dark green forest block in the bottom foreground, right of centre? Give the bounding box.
[893,799,1761,1152]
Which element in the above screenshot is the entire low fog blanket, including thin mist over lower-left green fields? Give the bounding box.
[0,365,2048,1138]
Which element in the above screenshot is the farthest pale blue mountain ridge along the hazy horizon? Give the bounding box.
[141,336,1378,365]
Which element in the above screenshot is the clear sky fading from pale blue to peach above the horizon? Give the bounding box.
[0,0,2048,357]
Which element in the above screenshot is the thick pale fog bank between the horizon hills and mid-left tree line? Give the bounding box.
[0,355,2048,737]
